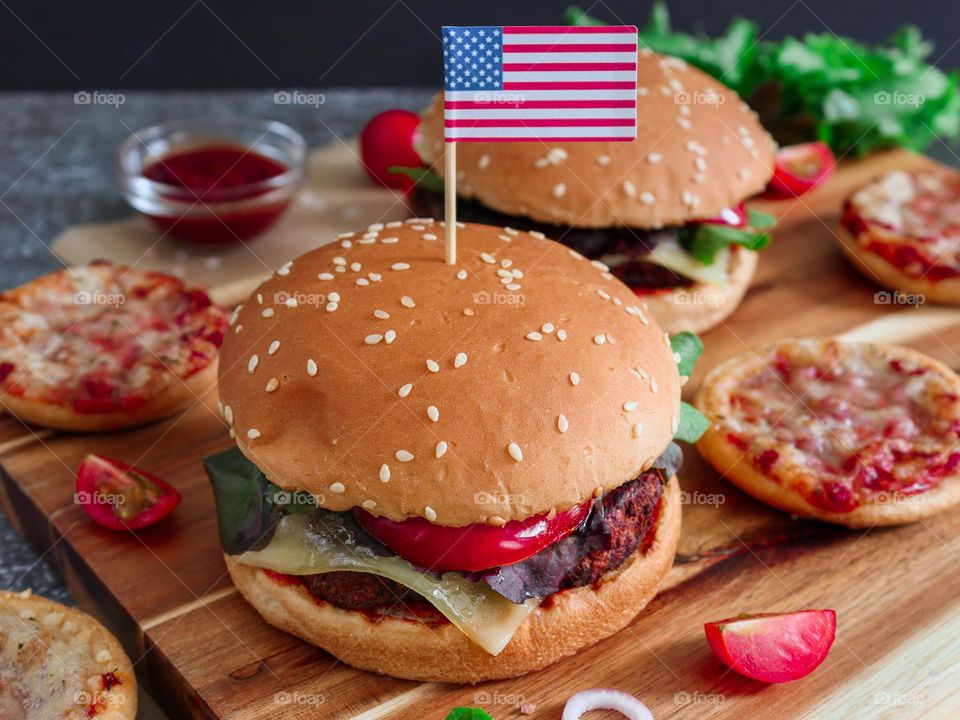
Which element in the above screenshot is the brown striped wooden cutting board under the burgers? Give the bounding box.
[0,148,960,720]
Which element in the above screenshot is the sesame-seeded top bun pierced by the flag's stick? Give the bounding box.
[220,219,680,526]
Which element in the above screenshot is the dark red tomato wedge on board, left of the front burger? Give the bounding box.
[75,455,180,530]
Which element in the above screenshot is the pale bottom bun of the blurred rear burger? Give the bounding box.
[640,245,757,334]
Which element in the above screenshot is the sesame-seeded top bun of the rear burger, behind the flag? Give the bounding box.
[415,50,776,228]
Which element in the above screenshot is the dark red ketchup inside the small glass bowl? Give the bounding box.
[141,143,291,243]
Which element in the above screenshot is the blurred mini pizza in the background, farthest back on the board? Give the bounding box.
[837,170,960,303]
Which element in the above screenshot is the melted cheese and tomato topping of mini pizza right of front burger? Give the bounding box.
[722,340,960,512]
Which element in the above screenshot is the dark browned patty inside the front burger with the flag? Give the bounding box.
[300,470,663,617]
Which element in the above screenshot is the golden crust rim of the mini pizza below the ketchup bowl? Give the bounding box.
[0,360,217,432]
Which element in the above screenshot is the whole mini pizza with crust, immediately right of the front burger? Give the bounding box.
[697,338,960,527]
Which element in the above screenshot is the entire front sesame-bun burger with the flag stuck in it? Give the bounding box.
[205,219,689,683]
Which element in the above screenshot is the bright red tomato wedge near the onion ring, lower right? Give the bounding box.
[703,610,837,683]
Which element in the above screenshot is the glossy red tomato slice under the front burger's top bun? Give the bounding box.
[353,501,591,572]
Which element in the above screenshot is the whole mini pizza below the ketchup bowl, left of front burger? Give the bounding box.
[0,262,227,432]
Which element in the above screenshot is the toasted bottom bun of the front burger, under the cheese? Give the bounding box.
[226,477,681,683]
